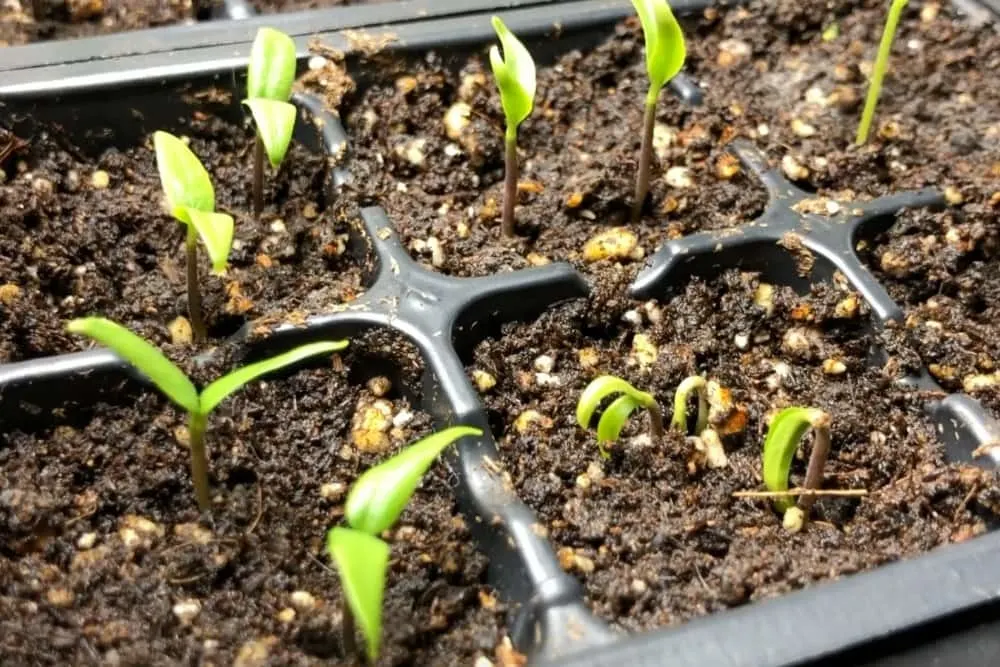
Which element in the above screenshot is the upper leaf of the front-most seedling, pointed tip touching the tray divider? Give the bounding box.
[344,426,483,535]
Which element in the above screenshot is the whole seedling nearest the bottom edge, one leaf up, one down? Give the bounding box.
[326,426,483,662]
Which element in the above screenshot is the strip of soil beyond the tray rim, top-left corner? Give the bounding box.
[0,0,203,47]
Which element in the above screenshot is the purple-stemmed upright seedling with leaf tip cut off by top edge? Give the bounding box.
[632,0,686,222]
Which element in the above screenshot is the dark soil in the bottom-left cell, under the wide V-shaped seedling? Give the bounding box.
[0,337,504,667]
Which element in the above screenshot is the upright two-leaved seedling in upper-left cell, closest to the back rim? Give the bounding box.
[243,28,297,215]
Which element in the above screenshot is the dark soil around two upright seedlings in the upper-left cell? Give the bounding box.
[0,104,361,362]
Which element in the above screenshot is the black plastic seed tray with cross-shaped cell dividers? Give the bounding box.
[0,0,1000,667]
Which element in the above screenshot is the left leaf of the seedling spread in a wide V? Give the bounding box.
[66,317,198,414]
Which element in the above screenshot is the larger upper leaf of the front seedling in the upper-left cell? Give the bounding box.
[153,131,215,223]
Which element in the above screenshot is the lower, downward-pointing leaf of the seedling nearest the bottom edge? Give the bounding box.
[326,527,389,663]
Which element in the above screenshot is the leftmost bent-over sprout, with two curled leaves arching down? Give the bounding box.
[576,375,663,458]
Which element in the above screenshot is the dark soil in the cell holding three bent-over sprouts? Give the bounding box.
[470,271,1000,631]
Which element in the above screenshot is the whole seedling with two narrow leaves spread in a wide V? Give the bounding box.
[66,317,347,512]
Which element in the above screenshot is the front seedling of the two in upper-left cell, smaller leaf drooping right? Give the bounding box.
[153,132,233,342]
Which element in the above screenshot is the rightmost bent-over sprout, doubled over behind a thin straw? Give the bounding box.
[763,408,830,532]
